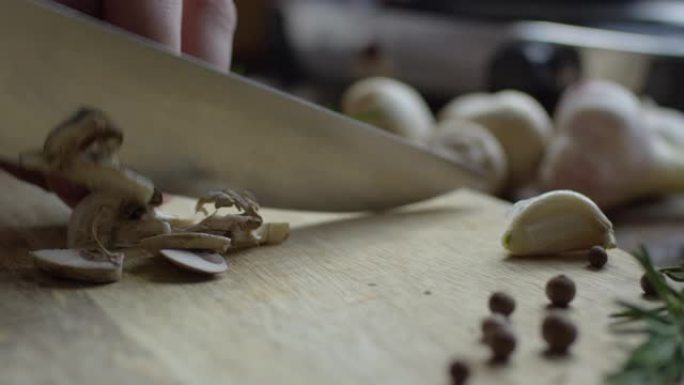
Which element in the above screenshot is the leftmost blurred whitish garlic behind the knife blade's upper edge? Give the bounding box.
[341,77,435,142]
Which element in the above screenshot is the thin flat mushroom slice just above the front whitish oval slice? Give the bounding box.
[140,233,231,253]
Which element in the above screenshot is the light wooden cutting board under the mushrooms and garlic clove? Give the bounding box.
[0,174,640,385]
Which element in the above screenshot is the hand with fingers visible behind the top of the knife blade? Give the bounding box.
[54,0,237,71]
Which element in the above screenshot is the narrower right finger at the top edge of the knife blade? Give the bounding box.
[181,0,237,71]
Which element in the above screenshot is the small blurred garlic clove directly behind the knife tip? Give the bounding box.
[426,119,508,194]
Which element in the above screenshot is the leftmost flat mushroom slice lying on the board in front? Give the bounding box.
[30,249,124,283]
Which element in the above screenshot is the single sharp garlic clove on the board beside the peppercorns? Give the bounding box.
[502,190,615,255]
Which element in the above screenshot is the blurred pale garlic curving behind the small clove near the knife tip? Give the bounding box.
[438,90,553,189]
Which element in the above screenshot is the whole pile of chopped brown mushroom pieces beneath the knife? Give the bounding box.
[20,109,289,282]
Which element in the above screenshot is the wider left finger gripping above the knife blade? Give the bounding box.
[102,0,183,53]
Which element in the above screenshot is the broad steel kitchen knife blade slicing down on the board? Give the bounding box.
[0,0,482,211]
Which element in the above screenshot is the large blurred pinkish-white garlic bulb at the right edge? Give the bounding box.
[540,81,684,208]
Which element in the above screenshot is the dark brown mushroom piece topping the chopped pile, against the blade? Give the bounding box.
[43,108,123,167]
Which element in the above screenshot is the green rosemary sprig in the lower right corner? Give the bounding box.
[606,247,684,385]
